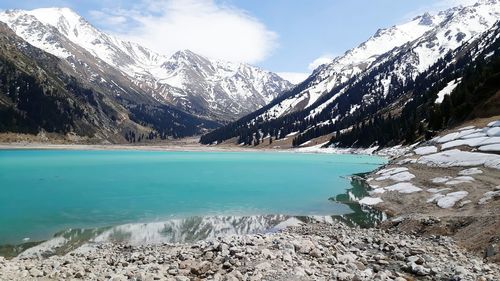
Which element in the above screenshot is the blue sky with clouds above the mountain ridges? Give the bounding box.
[0,0,474,82]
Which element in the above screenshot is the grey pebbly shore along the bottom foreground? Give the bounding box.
[0,222,500,281]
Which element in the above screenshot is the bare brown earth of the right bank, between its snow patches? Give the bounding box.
[367,116,500,263]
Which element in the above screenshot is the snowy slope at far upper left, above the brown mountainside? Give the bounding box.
[0,8,165,76]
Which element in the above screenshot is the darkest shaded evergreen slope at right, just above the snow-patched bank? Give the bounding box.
[332,26,500,147]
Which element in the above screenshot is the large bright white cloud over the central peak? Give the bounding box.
[95,0,278,63]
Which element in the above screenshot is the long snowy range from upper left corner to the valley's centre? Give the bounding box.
[0,8,292,120]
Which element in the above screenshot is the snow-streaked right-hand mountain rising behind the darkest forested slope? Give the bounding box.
[202,0,500,145]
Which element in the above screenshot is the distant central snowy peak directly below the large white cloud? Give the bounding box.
[148,50,292,119]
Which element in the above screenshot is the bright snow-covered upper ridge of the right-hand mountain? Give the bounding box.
[248,0,500,118]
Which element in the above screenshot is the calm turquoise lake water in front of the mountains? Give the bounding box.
[0,150,385,244]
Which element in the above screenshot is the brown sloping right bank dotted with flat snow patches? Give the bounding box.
[360,119,500,264]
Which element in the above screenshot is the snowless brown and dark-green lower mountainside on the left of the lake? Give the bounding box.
[0,23,218,143]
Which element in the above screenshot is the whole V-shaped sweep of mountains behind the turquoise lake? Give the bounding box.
[0,0,500,148]
